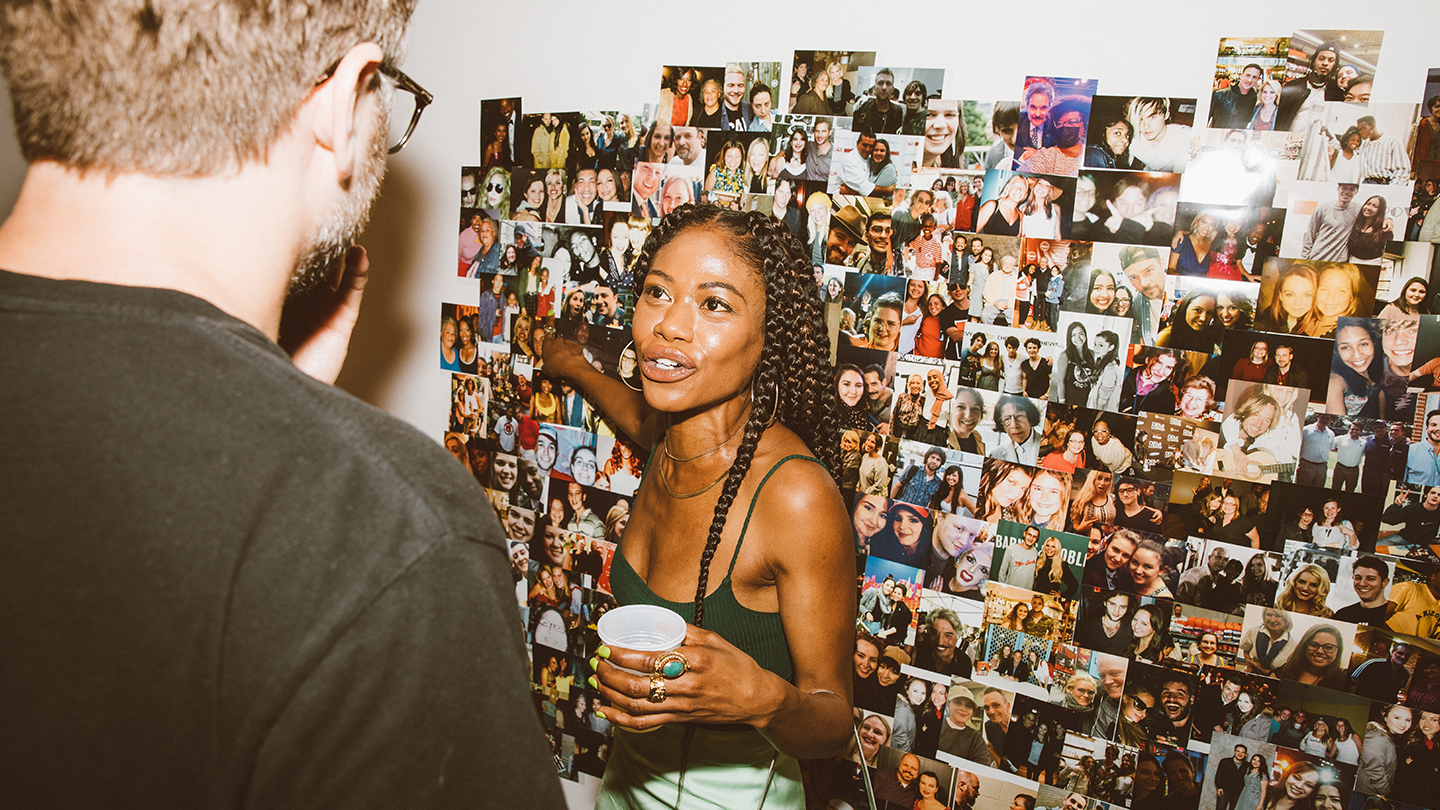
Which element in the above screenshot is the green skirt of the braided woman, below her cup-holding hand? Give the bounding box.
[595,724,805,810]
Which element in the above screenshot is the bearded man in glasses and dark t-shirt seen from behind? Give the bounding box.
[0,0,563,809]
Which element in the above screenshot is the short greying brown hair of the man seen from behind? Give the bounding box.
[0,0,415,177]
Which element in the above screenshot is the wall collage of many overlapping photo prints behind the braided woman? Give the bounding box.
[439,30,1440,810]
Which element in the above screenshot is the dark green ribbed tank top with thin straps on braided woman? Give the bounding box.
[611,455,822,680]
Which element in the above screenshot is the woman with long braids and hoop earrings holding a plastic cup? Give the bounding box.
[546,205,855,809]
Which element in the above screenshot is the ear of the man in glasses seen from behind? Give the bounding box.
[312,42,384,186]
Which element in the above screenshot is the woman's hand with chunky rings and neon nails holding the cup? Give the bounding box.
[590,624,788,729]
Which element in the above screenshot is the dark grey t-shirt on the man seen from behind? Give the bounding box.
[0,268,563,810]
